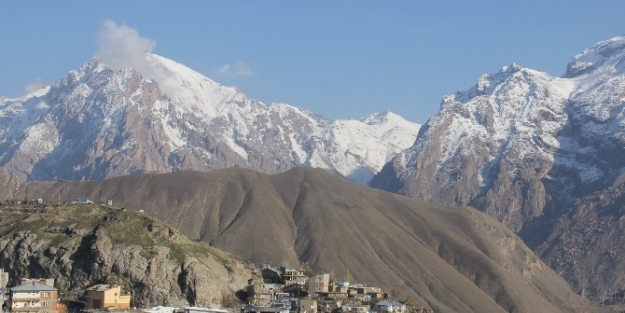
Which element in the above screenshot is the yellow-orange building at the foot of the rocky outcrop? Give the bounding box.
[85,284,131,310]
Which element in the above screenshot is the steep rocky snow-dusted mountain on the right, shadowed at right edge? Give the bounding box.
[370,37,625,301]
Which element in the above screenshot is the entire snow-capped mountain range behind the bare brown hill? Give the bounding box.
[0,31,625,311]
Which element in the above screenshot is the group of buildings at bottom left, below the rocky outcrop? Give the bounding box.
[0,271,131,313]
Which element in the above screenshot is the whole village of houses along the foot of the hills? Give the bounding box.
[0,264,433,313]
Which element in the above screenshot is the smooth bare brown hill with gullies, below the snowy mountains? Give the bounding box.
[0,168,610,313]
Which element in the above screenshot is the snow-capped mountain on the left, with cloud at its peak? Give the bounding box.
[0,54,420,183]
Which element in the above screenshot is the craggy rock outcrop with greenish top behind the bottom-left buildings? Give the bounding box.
[0,204,254,307]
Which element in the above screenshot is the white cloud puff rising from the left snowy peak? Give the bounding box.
[96,20,156,71]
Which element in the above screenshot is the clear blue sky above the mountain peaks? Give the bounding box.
[0,0,625,123]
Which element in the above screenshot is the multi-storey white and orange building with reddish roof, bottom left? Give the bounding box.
[9,280,58,313]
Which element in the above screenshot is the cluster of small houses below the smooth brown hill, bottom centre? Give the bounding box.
[241,264,431,313]
